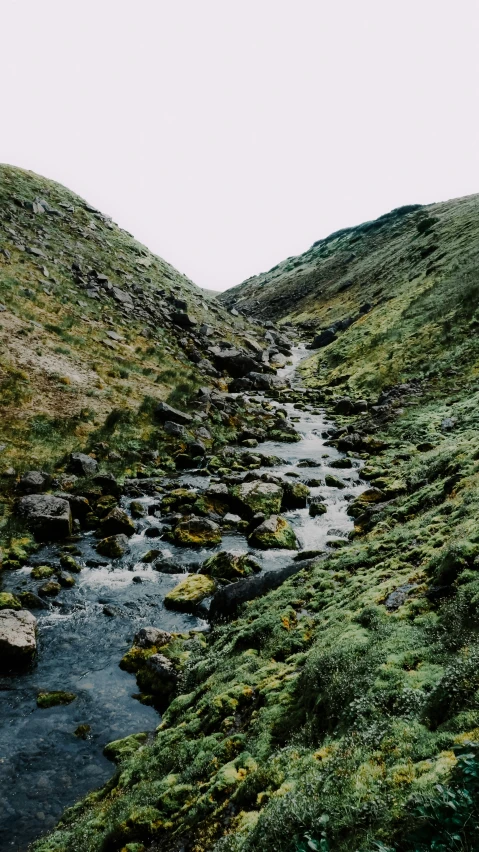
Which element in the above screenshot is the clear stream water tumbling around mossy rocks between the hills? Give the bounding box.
[0,347,366,852]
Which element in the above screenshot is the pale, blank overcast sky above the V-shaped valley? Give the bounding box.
[0,0,479,290]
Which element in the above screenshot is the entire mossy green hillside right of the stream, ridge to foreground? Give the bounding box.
[30,196,479,852]
